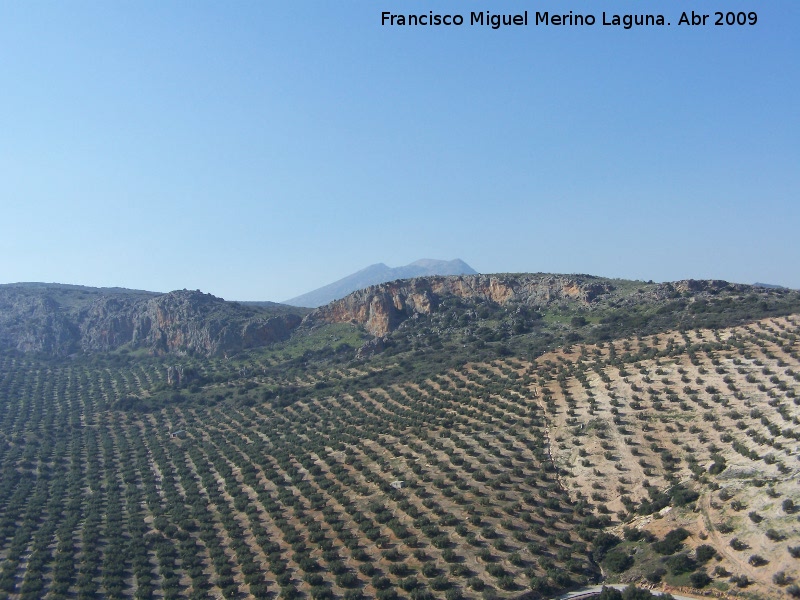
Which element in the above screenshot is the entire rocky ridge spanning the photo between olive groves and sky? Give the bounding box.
[0,273,800,358]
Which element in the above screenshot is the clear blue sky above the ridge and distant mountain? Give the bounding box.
[0,0,800,300]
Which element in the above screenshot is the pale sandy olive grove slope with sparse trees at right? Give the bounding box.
[539,318,800,598]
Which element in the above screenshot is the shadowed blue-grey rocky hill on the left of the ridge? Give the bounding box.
[0,284,302,356]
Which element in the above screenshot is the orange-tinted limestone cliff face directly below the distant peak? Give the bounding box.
[307,274,614,336]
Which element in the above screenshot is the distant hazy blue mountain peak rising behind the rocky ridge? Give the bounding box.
[284,258,477,308]
